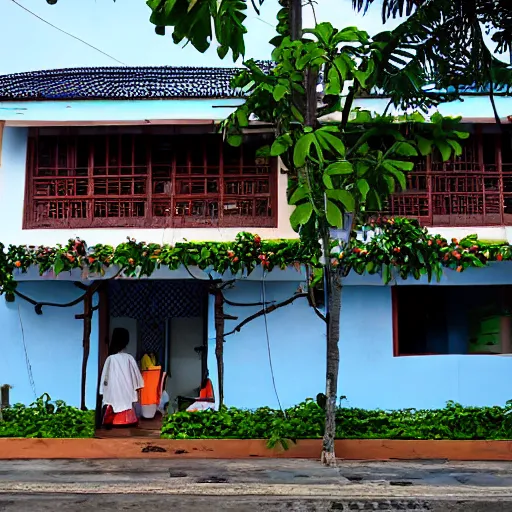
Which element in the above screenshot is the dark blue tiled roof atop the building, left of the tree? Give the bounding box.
[0,62,270,101]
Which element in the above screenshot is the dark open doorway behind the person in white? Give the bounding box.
[98,280,208,435]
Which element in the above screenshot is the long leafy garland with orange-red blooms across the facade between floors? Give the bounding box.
[0,218,512,293]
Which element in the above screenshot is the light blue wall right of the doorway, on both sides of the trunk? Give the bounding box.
[209,283,512,409]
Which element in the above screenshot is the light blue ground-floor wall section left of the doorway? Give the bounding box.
[0,282,98,408]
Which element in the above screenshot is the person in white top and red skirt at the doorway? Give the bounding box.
[100,327,144,428]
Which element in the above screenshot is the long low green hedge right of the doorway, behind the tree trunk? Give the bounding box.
[162,399,512,445]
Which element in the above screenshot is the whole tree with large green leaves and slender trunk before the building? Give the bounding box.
[217,16,467,464]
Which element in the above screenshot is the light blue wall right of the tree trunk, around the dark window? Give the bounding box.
[339,286,512,409]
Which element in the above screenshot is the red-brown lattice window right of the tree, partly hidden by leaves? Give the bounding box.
[386,131,512,226]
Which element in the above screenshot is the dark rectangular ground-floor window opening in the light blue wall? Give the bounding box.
[393,285,512,356]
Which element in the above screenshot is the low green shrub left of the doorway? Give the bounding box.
[0,394,95,438]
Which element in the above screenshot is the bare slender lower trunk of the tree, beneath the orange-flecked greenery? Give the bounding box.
[322,265,341,466]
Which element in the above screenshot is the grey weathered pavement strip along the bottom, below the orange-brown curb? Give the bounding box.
[0,459,512,512]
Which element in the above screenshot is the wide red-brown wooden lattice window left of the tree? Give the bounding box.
[25,131,277,229]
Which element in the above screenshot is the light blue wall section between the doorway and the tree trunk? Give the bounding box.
[208,281,325,408]
